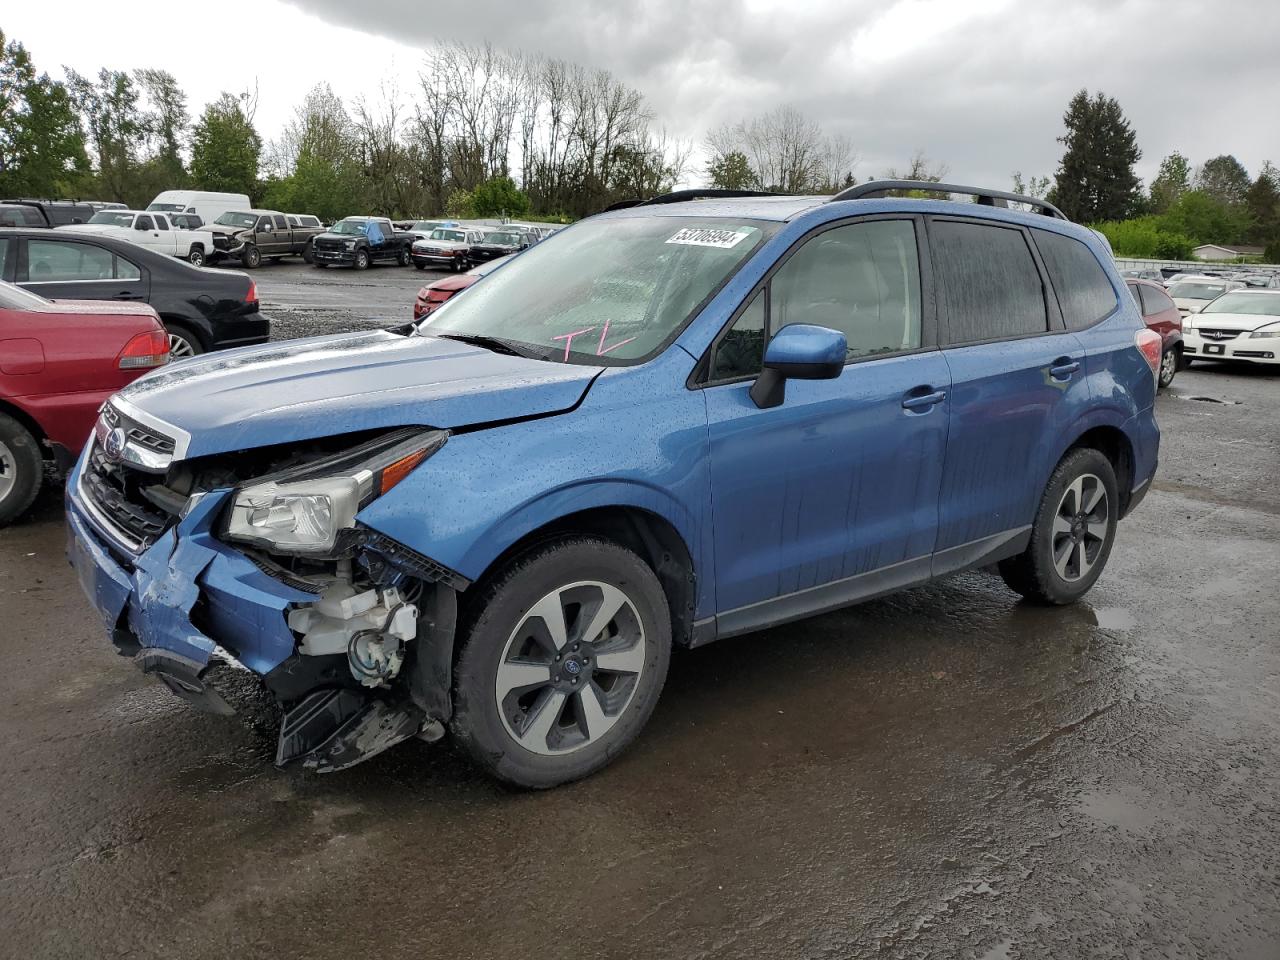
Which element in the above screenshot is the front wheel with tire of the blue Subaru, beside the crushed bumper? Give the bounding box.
[451,538,671,788]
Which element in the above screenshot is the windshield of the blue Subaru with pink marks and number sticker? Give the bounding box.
[419,216,778,364]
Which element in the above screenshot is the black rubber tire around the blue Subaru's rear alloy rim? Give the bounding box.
[1000,447,1120,605]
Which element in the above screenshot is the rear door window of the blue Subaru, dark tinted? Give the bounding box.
[929,220,1048,344]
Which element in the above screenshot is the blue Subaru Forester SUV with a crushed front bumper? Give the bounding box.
[68,182,1160,787]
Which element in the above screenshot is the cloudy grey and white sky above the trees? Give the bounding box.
[0,0,1280,187]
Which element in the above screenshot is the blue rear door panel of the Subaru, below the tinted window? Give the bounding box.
[937,333,1089,550]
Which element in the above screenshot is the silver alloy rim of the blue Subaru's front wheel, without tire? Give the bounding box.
[494,580,645,756]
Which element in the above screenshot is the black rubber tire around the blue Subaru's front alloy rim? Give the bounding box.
[449,538,671,790]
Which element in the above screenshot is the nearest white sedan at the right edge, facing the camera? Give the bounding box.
[1183,289,1280,364]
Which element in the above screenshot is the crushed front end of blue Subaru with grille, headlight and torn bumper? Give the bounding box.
[67,398,467,771]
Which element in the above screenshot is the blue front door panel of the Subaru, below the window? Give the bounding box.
[704,351,950,612]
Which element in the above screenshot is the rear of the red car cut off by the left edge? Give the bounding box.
[0,283,169,526]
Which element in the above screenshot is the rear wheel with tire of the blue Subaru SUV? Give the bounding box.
[1000,447,1120,605]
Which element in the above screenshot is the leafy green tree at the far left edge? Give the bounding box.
[0,31,88,197]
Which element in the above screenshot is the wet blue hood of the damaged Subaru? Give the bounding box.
[120,330,602,457]
